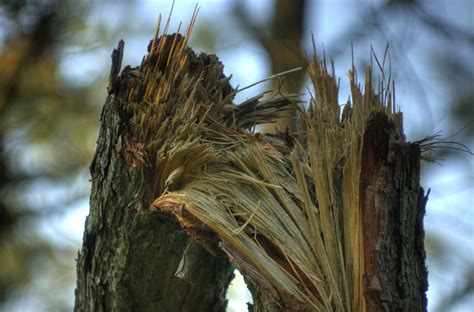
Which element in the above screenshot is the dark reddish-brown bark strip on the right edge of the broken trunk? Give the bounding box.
[360,113,428,311]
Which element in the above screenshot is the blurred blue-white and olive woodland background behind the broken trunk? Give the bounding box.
[0,0,474,311]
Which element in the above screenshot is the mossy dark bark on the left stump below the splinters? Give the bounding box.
[75,42,233,311]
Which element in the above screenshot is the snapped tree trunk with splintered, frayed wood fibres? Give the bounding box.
[76,17,427,311]
